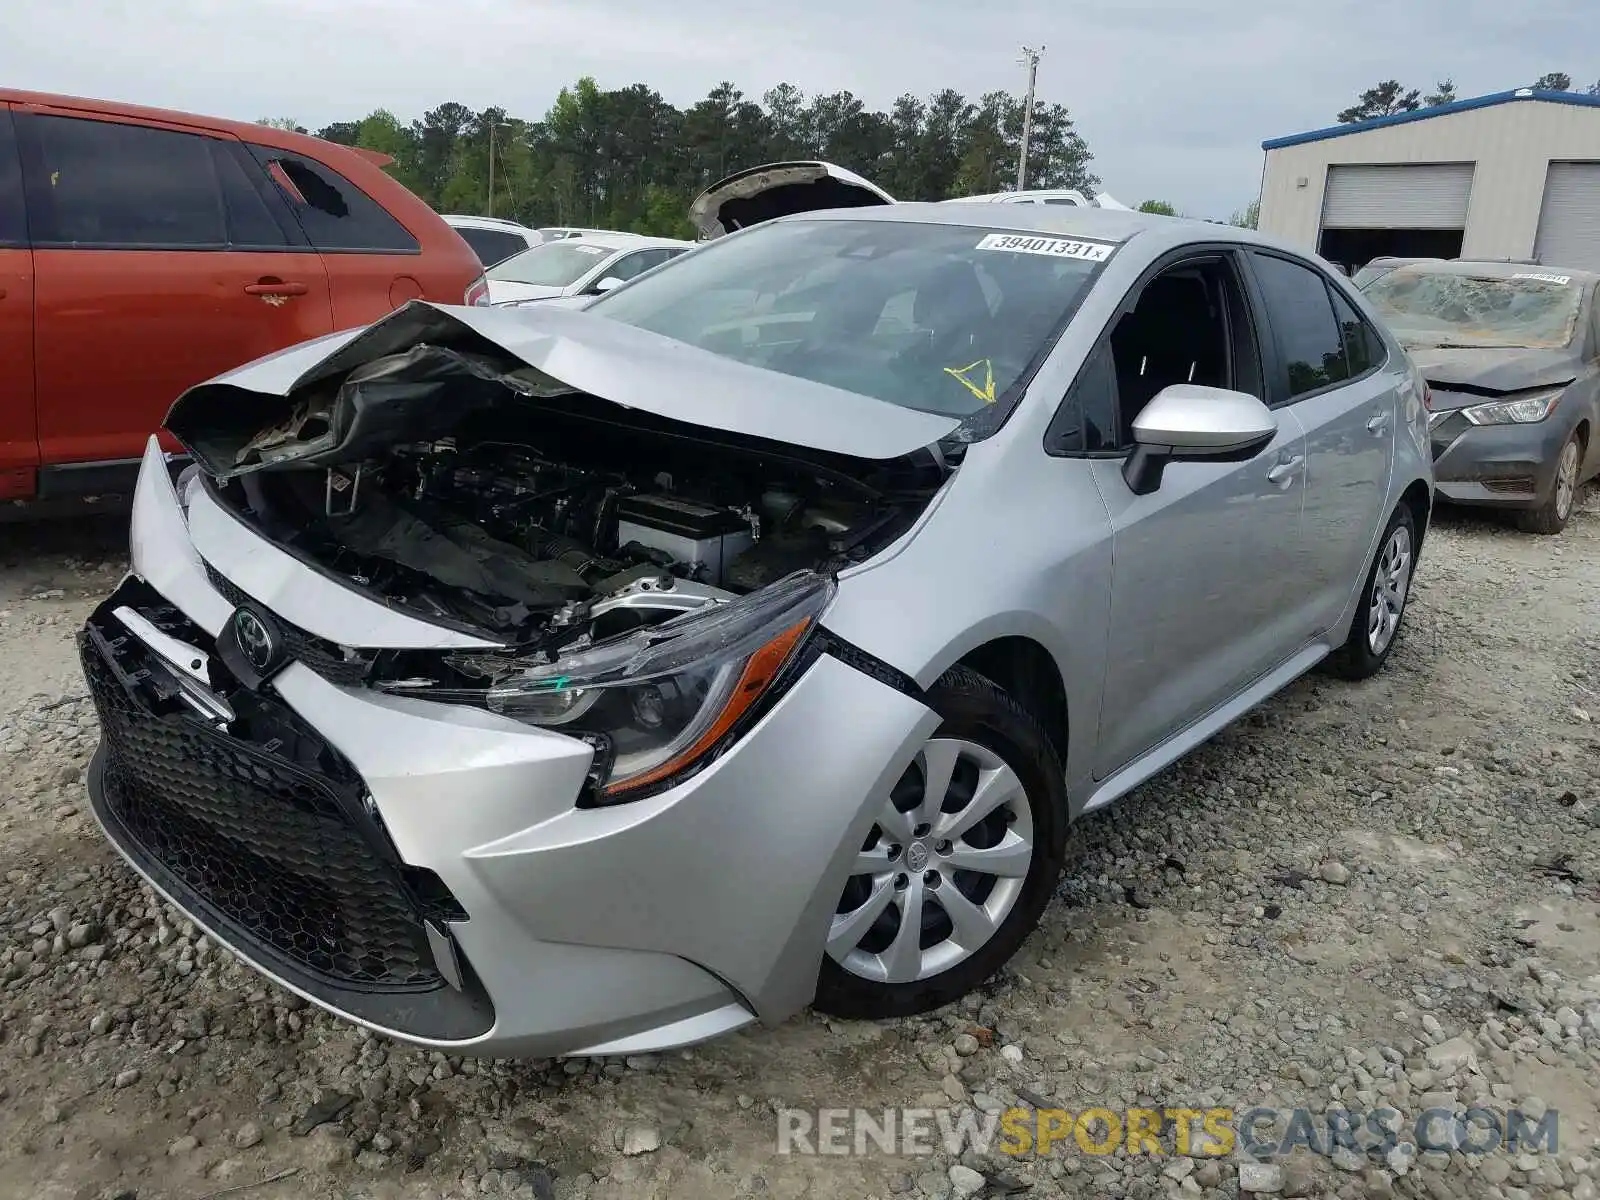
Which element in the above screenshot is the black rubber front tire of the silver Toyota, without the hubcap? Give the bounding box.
[813,667,1067,1019]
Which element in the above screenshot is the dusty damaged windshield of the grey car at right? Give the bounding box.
[1365,267,1582,350]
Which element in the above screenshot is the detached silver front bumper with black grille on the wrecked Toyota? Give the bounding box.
[83,442,938,1056]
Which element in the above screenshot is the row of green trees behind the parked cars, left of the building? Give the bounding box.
[262,78,1099,237]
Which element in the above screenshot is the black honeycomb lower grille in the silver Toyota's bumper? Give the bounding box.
[80,594,443,990]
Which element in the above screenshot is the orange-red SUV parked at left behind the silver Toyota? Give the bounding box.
[0,88,486,499]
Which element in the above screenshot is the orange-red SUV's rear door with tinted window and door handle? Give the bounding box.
[18,106,333,467]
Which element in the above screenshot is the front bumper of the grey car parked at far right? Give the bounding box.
[1429,410,1571,509]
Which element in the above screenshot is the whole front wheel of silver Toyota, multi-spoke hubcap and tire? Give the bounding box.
[814,667,1067,1018]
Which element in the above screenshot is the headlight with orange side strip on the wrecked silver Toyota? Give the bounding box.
[389,571,834,803]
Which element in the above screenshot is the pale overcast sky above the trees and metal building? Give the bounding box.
[0,0,1600,218]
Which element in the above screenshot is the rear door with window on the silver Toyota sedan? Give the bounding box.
[1246,250,1400,638]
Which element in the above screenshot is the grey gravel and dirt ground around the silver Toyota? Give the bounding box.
[0,504,1600,1200]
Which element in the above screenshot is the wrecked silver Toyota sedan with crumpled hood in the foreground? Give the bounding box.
[82,200,1432,1056]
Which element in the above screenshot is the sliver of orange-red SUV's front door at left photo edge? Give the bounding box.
[0,104,38,499]
